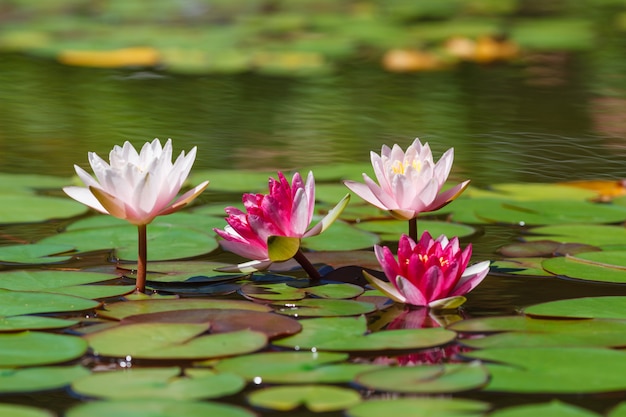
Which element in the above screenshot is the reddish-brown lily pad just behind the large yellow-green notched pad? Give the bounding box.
[121,308,302,339]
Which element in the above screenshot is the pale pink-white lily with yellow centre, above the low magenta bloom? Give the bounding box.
[344,139,469,220]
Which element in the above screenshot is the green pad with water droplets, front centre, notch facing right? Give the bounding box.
[214,351,380,384]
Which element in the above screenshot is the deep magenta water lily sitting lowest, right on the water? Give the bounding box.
[364,232,489,309]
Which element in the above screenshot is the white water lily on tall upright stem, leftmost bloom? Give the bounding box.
[63,139,209,225]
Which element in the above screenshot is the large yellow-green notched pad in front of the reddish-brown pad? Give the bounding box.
[85,323,267,360]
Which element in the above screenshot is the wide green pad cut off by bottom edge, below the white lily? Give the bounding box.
[65,398,256,417]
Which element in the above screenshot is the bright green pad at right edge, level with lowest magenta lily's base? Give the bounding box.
[524,296,626,319]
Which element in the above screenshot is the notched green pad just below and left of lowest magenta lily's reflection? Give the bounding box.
[274,316,456,352]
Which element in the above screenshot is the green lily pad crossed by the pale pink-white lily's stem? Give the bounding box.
[355,219,476,241]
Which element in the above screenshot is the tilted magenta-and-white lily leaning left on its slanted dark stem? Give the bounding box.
[214,172,349,278]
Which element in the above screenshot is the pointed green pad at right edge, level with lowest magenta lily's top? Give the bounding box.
[542,251,626,283]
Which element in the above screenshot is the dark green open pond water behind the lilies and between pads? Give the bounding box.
[0,44,626,416]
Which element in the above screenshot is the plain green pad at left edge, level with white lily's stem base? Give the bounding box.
[0,288,100,317]
